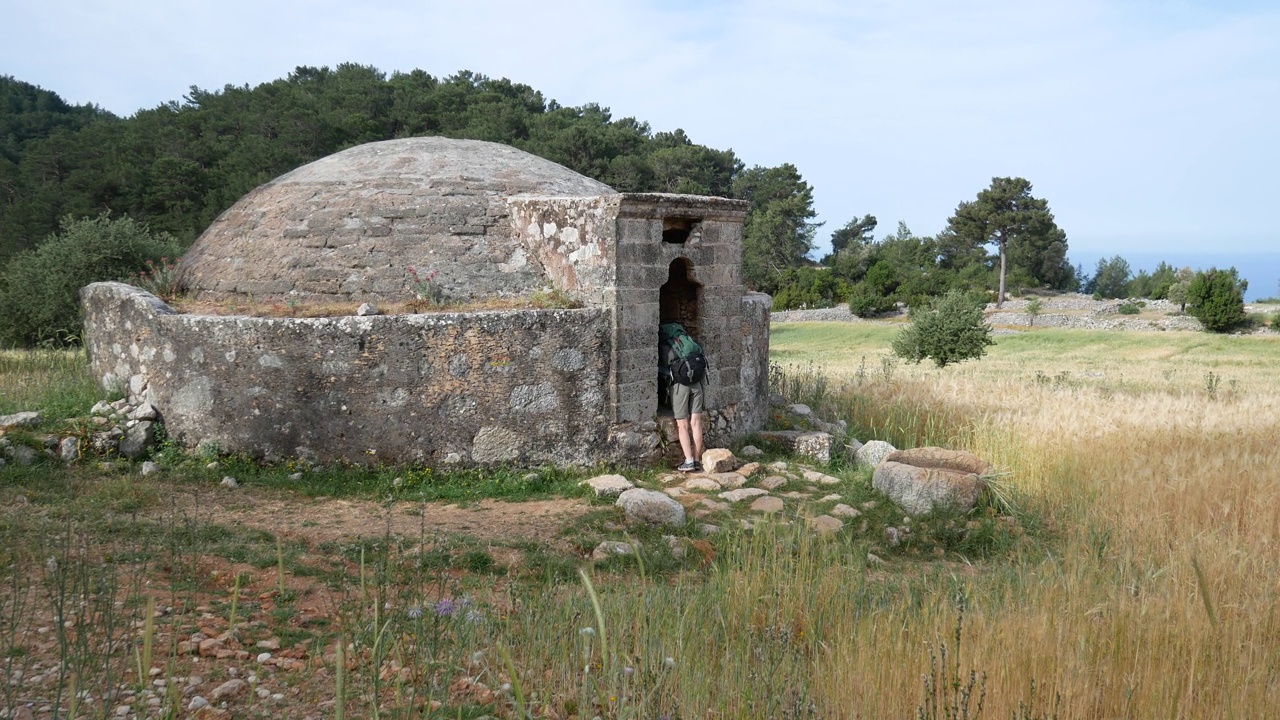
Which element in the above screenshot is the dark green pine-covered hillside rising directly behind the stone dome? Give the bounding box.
[0,63,798,283]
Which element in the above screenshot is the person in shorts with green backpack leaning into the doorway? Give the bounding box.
[658,323,707,473]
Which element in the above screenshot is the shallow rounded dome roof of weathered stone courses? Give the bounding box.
[179,137,616,300]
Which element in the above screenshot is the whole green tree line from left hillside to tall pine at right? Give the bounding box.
[0,64,1239,345]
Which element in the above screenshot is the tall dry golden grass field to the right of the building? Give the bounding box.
[773,324,1280,717]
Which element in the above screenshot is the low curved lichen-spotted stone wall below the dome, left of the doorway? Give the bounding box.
[82,283,624,465]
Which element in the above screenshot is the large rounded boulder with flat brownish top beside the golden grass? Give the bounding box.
[868,443,991,516]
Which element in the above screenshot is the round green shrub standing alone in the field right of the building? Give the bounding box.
[893,290,995,368]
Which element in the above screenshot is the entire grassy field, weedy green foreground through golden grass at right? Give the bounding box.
[0,323,1280,719]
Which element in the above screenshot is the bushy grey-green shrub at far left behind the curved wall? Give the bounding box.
[0,213,179,346]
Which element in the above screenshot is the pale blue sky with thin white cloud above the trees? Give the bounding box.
[0,0,1280,288]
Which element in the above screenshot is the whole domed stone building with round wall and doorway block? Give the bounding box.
[82,137,771,465]
